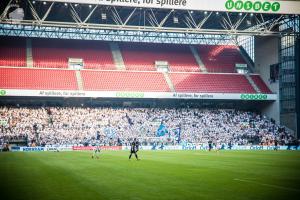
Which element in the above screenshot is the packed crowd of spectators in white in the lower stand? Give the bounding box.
[0,107,293,145]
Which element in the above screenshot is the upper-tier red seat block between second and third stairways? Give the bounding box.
[119,43,200,72]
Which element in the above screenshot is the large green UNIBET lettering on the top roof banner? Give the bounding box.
[225,0,280,12]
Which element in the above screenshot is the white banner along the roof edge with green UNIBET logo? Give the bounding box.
[38,0,300,14]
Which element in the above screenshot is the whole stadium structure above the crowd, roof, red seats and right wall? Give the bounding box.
[0,0,300,138]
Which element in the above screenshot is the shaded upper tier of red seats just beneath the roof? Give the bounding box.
[0,37,246,73]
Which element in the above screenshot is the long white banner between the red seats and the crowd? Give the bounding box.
[0,89,277,101]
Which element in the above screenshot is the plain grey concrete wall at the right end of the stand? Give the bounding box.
[254,36,280,123]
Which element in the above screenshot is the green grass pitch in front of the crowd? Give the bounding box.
[0,151,300,200]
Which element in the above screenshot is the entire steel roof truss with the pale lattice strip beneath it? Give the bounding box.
[0,0,299,44]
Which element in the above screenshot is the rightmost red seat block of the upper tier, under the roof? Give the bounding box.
[198,45,246,73]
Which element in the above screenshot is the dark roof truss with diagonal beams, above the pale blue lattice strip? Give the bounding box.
[0,0,300,36]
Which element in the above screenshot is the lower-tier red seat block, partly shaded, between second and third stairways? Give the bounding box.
[170,73,256,93]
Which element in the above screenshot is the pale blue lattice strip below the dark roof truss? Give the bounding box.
[0,24,234,45]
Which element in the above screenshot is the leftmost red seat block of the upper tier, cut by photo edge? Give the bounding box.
[0,37,26,67]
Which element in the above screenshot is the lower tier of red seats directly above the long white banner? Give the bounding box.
[0,67,272,94]
